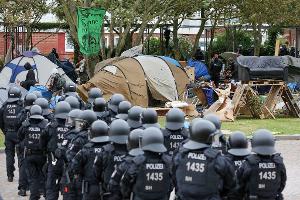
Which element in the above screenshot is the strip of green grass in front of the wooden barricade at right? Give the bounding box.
[159,117,300,135]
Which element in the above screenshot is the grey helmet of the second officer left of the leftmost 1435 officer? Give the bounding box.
[109,119,130,144]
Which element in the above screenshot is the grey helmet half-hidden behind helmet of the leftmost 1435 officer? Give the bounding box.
[127,129,144,156]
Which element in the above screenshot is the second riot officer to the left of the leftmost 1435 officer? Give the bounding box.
[94,119,130,197]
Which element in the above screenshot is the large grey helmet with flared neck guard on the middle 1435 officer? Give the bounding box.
[183,119,216,149]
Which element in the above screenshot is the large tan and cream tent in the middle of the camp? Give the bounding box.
[79,55,189,107]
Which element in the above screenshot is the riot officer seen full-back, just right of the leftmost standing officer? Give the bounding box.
[18,105,48,200]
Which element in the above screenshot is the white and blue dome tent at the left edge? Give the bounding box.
[0,51,70,88]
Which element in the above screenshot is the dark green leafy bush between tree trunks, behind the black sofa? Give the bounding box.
[213,29,253,55]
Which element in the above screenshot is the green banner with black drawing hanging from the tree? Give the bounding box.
[77,8,105,56]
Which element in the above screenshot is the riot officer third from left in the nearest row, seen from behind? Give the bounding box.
[46,101,71,200]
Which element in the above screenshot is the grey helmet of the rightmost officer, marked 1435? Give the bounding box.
[251,129,276,155]
